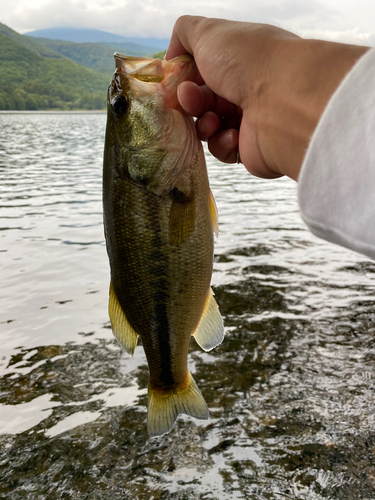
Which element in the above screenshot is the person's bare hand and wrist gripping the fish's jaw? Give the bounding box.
[166,16,367,180]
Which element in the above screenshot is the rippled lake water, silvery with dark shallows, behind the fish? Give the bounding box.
[0,114,375,500]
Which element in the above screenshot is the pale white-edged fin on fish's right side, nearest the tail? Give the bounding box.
[193,289,224,351]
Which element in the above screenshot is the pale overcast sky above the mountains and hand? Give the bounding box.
[0,0,375,45]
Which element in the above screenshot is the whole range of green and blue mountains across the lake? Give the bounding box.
[0,23,164,110]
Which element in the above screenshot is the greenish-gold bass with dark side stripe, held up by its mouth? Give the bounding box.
[103,53,224,436]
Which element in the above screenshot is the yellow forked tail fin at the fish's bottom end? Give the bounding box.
[147,373,209,436]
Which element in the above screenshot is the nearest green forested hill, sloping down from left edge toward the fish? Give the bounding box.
[0,24,112,110]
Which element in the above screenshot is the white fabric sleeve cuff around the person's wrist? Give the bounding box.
[298,49,375,259]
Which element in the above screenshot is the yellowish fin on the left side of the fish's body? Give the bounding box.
[108,282,138,356]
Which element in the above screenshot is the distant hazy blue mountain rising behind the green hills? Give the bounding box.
[24,28,169,53]
